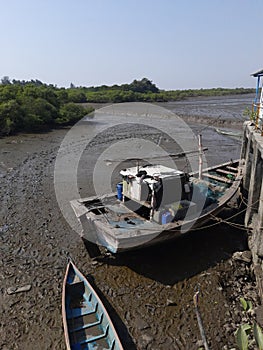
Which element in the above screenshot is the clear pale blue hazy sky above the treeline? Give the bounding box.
[0,0,263,89]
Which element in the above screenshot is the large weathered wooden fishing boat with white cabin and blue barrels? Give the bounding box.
[71,160,243,253]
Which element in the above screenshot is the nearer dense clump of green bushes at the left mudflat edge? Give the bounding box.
[0,77,94,135]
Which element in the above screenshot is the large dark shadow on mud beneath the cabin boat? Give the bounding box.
[95,220,248,285]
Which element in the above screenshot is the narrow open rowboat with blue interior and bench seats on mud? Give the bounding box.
[62,261,123,350]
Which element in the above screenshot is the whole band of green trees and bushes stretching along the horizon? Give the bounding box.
[0,76,254,135]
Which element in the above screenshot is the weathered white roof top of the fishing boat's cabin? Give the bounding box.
[120,164,184,178]
